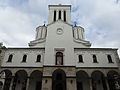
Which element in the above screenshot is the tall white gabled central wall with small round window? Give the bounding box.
[44,21,75,66]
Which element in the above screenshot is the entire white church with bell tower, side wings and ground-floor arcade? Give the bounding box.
[0,5,120,90]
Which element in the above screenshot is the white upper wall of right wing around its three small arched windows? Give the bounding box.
[75,48,118,67]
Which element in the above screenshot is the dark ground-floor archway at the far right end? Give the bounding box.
[107,71,120,90]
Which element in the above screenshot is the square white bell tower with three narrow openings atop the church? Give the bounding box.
[48,4,71,24]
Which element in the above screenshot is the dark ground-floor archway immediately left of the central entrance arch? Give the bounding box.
[29,70,42,90]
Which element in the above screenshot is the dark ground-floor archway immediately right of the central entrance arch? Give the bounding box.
[76,71,90,90]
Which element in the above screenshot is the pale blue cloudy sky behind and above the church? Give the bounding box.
[0,0,120,55]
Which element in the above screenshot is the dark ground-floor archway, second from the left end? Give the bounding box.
[12,70,28,90]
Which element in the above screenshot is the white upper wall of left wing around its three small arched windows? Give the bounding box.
[1,49,44,67]
